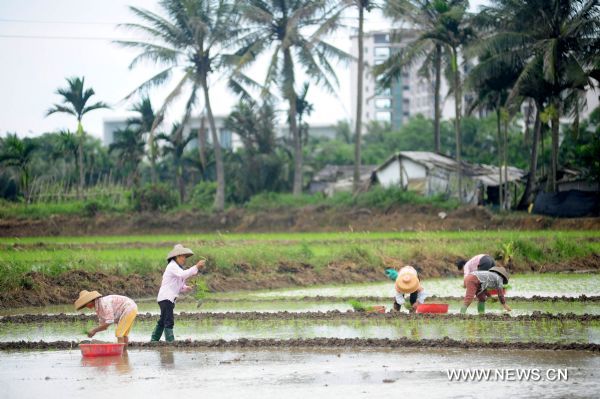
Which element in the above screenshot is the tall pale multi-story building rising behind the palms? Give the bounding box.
[350,29,434,133]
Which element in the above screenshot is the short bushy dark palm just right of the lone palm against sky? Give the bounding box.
[108,128,145,187]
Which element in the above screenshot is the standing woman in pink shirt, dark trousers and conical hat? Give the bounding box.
[151,244,205,342]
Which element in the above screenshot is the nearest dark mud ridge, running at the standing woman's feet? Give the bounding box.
[0,337,600,352]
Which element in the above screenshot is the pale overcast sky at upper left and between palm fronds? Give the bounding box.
[0,0,484,138]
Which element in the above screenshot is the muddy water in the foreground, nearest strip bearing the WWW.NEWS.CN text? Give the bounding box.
[0,348,600,399]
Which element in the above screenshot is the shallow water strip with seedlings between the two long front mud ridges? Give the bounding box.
[0,317,600,344]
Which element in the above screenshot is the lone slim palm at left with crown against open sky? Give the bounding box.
[46,77,109,197]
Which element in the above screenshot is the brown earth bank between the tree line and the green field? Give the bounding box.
[0,205,600,237]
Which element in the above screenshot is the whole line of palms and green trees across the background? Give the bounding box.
[0,0,600,211]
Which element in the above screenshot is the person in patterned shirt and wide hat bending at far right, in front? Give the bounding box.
[460,266,511,314]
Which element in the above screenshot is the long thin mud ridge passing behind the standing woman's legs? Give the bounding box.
[0,310,600,324]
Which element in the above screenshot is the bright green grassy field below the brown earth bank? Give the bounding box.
[0,231,600,289]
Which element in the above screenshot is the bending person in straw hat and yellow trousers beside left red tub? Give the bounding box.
[75,290,137,344]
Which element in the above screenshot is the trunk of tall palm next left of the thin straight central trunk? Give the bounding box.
[283,48,302,195]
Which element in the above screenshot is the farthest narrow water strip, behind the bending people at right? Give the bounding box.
[222,273,600,298]
